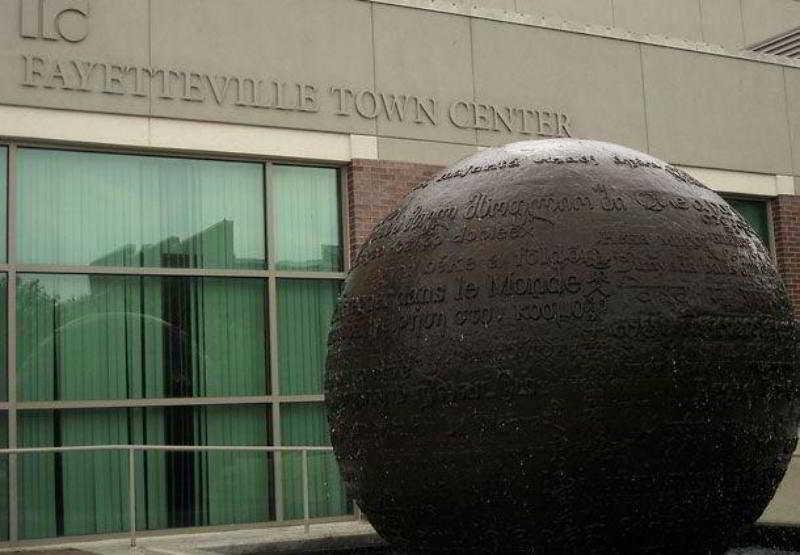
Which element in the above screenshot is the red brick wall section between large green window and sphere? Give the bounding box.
[347,160,442,258]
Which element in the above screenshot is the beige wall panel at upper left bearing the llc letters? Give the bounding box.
[0,0,149,114]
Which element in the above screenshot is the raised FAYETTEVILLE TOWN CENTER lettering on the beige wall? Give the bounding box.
[20,54,572,137]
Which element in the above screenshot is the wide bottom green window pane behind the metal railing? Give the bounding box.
[19,405,272,539]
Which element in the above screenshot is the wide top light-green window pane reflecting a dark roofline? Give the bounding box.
[17,149,266,268]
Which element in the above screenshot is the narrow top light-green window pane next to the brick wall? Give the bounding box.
[272,166,342,271]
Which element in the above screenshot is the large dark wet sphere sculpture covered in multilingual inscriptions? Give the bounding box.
[326,140,800,553]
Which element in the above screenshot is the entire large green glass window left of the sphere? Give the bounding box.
[8,147,352,539]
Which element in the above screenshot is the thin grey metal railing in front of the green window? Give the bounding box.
[0,445,361,547]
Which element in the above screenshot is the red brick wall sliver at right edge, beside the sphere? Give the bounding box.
[771,195,800,316]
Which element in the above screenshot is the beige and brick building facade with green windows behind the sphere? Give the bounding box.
[0,0,800,541]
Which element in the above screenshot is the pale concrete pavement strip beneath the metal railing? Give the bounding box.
[0,522,383,555]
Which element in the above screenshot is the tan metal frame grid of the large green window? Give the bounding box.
[0,138,350,543]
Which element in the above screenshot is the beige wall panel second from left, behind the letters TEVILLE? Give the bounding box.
[152,0,375,133]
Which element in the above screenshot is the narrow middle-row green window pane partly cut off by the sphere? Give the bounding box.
[277,279,340,395]
